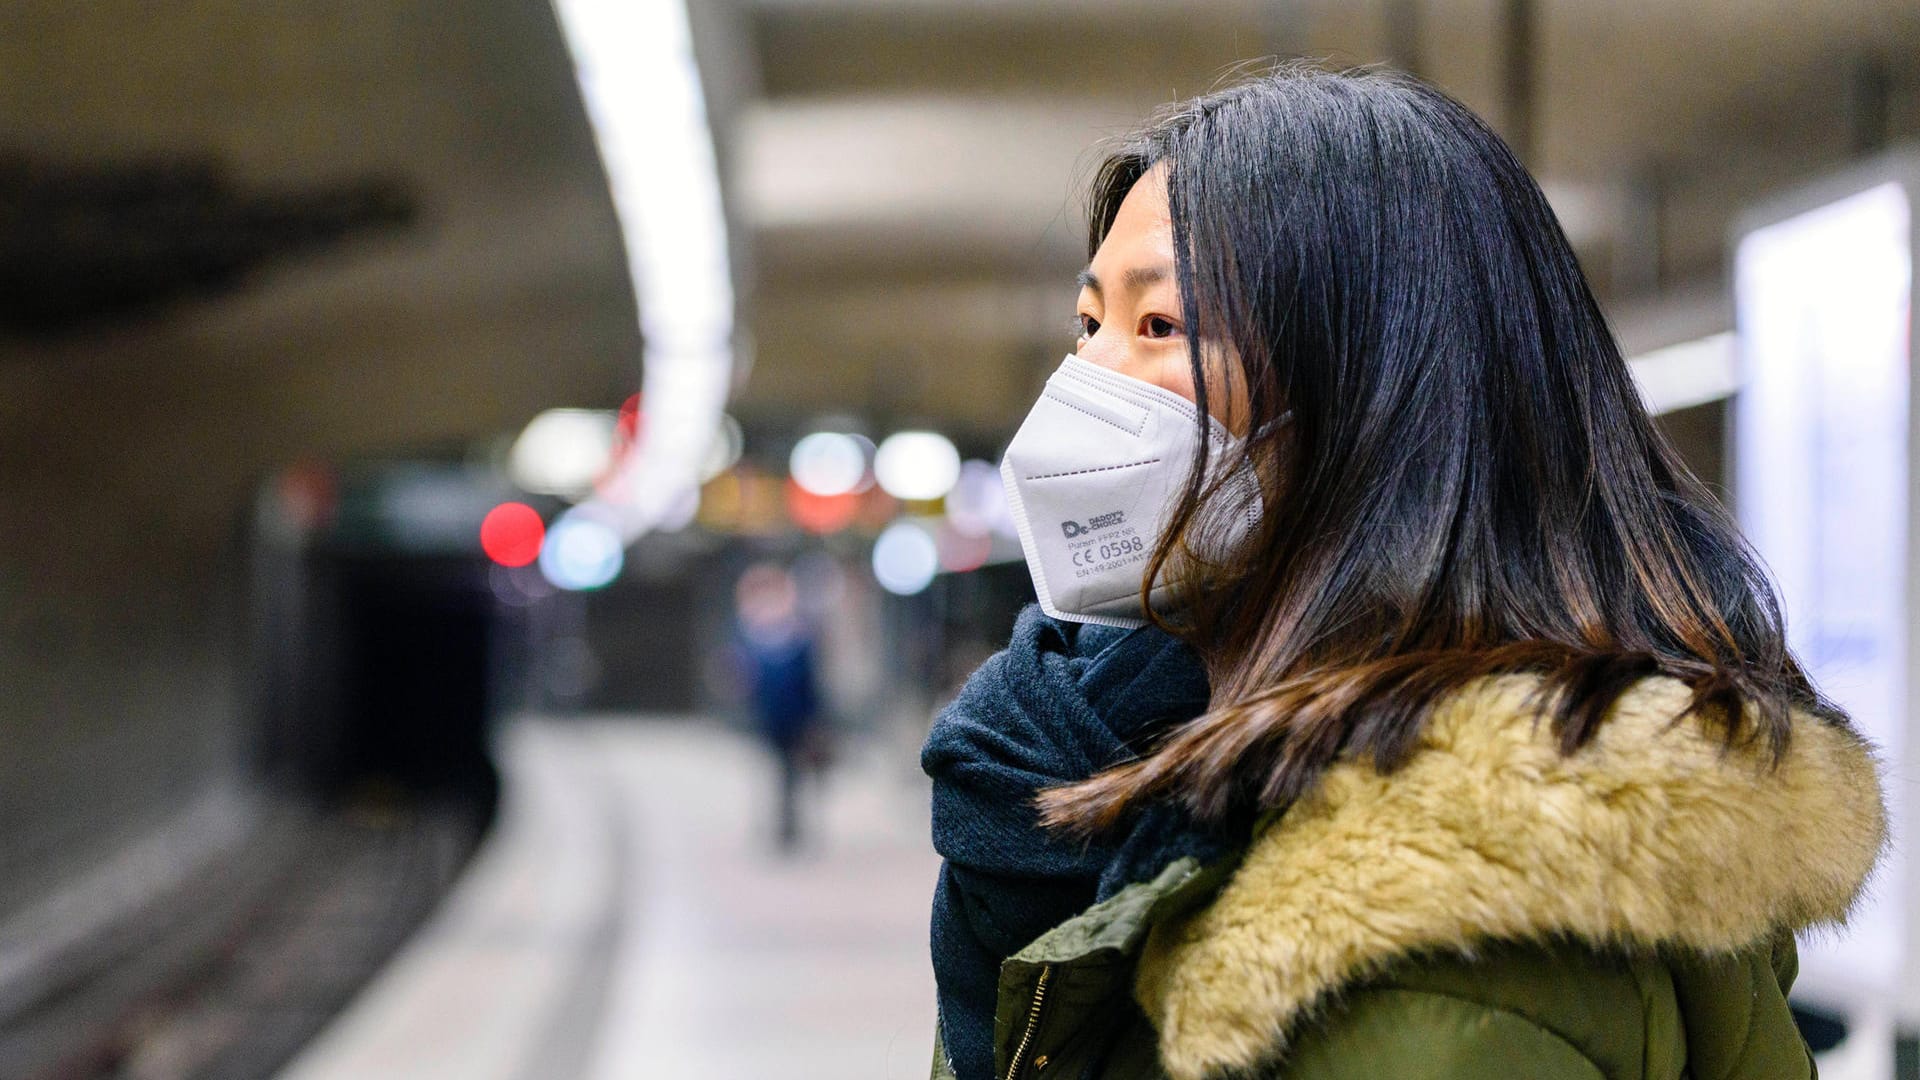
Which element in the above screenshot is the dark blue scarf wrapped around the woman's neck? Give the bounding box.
[920,607,1229,1080]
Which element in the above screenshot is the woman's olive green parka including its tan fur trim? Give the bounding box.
[933,676,1885,1080]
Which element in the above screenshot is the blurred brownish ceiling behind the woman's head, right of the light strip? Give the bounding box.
[720,0,1920,442]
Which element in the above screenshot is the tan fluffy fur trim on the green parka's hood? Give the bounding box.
[1135,676,1885,1080]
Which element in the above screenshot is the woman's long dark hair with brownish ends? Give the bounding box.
[1041,65,1841,832]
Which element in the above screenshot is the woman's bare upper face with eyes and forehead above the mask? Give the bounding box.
[1073,165,1246,434]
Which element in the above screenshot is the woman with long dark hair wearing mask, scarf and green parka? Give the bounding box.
[924,67,1884,1080]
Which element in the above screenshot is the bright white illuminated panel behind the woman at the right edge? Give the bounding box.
[1734,169,1920,1019]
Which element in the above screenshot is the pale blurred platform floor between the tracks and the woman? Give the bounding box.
[280,719,937,1080]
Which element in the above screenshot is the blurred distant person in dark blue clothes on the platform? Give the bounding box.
[733,563,820,851]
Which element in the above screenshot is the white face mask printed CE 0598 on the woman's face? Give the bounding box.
[1000,356,1261,626]
